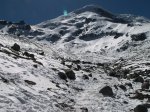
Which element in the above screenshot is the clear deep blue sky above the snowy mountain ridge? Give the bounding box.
[0,0,150,24]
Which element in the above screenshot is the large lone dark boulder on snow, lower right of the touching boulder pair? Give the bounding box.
[99,86,114,97]
